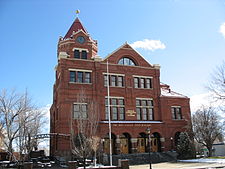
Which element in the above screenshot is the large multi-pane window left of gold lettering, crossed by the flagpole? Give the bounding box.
[105,97,125,120]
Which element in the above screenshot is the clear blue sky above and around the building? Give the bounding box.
[0,0,225,106]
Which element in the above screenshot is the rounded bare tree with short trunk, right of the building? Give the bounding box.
[192,106,224,156]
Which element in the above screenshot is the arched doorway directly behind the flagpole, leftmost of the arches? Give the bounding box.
[103,133,116,154]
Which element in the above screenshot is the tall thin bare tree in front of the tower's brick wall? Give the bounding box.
[71,89,100,168]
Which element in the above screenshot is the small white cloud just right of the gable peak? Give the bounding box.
[131,39,166,51]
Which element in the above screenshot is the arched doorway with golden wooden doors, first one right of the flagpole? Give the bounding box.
[120,133,131,154]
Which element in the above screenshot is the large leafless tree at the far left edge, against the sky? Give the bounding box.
[0,89,45,160]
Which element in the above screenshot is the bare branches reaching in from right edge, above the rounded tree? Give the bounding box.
[207,61,225,110]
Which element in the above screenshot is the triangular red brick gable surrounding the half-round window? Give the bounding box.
[103,43,153,67]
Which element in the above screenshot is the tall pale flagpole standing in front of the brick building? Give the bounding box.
[107,59,112,166]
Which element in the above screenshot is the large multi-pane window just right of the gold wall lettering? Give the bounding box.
[136,98,154,120]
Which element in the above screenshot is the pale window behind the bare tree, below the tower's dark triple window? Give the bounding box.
[73,103,88,119]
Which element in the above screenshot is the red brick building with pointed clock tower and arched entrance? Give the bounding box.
[50,18,190,156]
